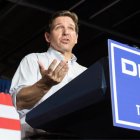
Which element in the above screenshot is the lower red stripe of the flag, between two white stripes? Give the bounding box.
[0,118,21,130]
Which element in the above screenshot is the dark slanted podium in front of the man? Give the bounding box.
[26,57,140,138]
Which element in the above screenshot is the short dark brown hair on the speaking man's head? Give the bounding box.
[47,10,79,34]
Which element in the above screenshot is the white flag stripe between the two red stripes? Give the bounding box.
[0,104,19,120]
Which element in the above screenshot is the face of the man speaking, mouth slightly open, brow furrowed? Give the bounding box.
[48,16,78,53]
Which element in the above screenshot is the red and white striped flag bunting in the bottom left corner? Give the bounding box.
[0,93,21,140]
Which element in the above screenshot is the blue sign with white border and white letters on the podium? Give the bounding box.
[108,39,140,130]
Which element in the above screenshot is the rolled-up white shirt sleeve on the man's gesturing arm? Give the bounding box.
[9,53,39,117]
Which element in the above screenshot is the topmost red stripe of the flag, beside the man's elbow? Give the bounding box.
[0,92,13,106]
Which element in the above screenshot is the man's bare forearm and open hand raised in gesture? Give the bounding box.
[16,60,68,110]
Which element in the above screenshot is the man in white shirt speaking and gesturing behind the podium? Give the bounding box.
[10,11,86,137]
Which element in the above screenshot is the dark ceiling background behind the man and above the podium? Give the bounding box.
[0,0,140,79]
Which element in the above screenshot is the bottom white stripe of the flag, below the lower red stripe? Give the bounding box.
[0,129,21,140]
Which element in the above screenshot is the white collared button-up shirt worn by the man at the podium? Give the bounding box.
[10,47,87,138]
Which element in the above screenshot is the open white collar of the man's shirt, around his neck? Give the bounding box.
[47,47,77,62]
